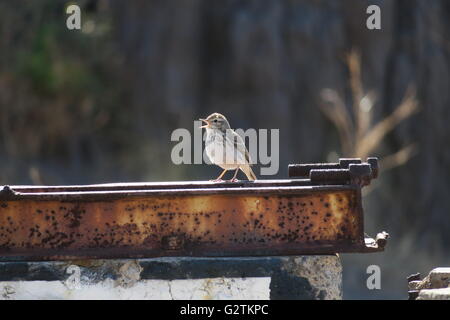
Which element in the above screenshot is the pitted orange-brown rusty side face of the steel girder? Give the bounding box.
[0,190,363,256]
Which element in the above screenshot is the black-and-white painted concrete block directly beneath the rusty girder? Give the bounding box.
[0,255,342,300]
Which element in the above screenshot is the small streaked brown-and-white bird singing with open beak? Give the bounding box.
[199,112,256,182]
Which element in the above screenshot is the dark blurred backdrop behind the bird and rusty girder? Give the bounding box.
[0,0,450,299]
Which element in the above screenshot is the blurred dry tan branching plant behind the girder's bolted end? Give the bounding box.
[320,50,419,175]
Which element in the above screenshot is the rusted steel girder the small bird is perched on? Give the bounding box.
[0,157,386,261]
